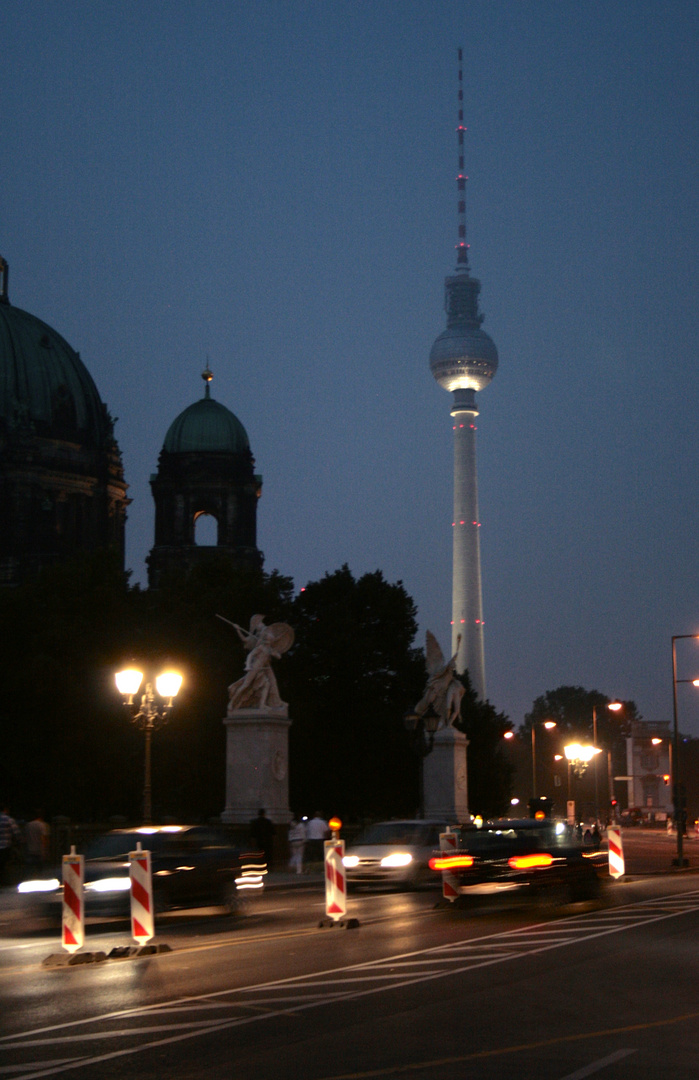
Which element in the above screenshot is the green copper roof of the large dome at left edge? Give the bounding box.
[0,295,111,449]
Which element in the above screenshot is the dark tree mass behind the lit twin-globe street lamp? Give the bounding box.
[0,556,292,821]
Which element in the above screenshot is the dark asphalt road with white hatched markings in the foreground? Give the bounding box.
[0,846,699,1080]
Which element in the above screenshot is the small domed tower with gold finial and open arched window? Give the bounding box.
[148,368,263,588]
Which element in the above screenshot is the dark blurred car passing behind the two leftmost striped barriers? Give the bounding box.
[17,825,266,916]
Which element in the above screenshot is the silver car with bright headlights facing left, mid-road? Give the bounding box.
[342,819,447,889]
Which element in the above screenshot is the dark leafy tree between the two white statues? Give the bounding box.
[280,566,426,820]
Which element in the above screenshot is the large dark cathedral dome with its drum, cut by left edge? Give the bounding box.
[0,258,129,585]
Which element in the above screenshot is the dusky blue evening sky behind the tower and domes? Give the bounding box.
[0,0,699,735]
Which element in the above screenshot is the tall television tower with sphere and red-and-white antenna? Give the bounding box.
[430,49,498,699]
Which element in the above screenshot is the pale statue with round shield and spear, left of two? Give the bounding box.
[218,615,294,716]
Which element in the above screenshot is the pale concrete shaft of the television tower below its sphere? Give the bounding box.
[452,390,485,699]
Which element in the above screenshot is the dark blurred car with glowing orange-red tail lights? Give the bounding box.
[430,818,607,903]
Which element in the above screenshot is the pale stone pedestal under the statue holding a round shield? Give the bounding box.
[220,705,292,825]
